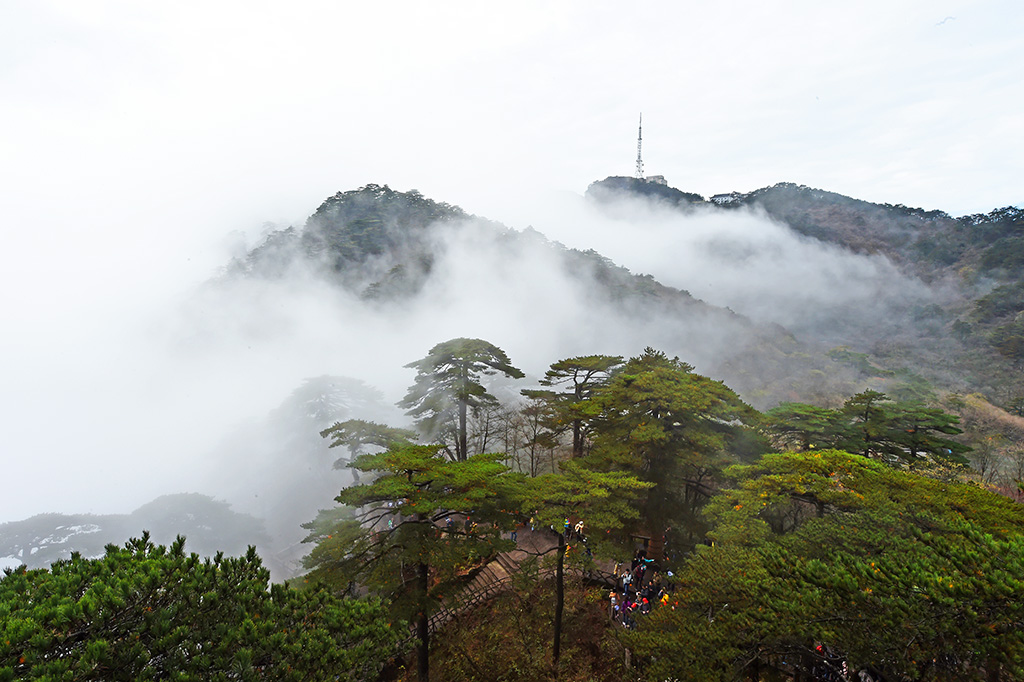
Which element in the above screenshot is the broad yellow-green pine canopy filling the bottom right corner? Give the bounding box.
[634,451,1024,680]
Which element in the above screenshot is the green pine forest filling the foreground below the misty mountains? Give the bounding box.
[8,338,1024,680]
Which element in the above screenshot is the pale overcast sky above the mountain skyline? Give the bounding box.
[0,0,1024,521]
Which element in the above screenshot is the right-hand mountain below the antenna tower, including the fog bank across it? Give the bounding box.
[569,178,1024,399]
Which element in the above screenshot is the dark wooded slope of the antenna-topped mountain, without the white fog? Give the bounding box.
[588,177,1024,404]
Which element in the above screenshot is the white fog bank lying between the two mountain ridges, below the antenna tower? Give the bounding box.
[534,189,944,341]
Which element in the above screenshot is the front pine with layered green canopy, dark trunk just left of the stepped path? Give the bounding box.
[305,442,521,682]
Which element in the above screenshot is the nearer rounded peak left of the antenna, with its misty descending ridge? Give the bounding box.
[227,185,868,406]
